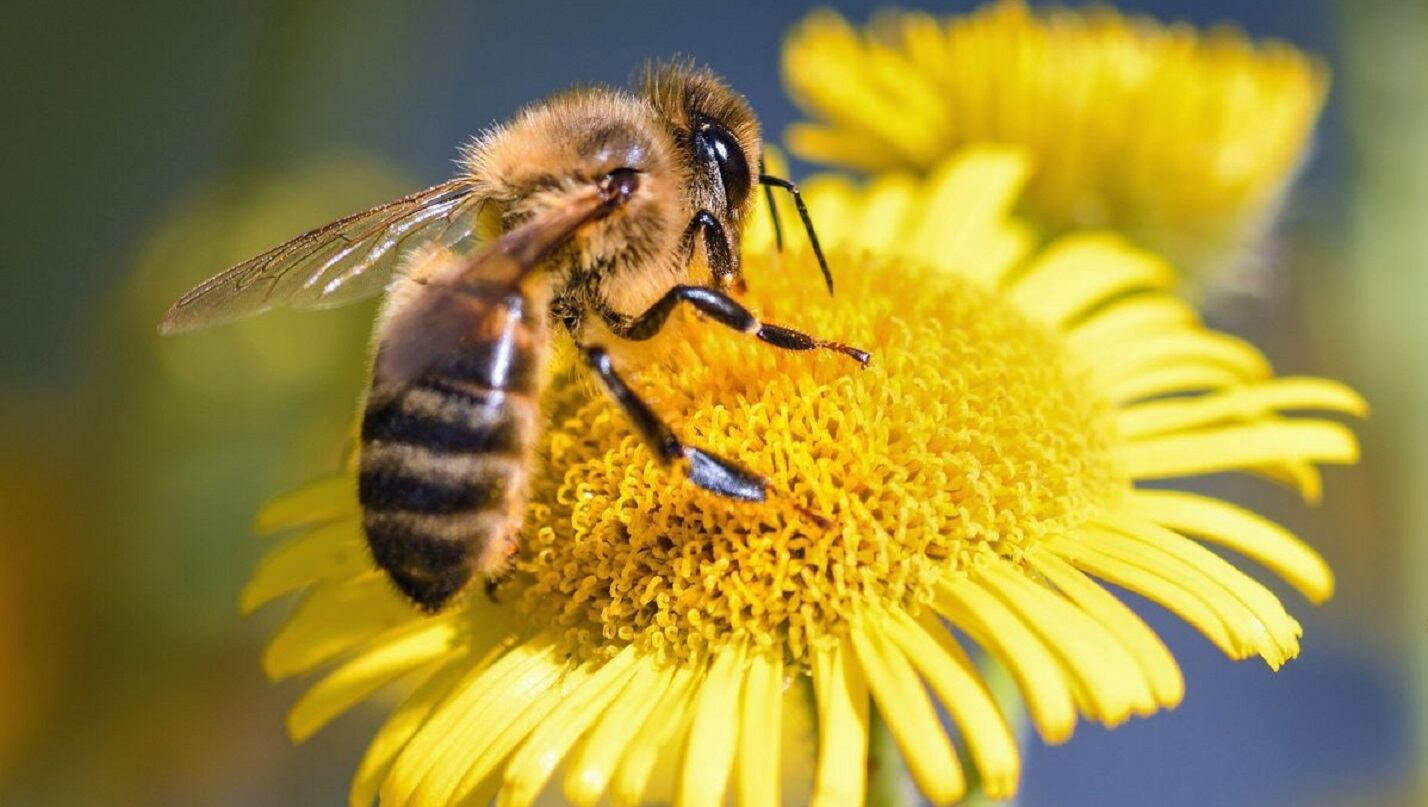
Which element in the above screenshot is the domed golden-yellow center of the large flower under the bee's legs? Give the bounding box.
[513,254,1124,663]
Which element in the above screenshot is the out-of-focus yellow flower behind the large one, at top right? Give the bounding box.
[784,0,1327,280]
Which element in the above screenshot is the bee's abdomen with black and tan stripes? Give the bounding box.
[358,294,545,611]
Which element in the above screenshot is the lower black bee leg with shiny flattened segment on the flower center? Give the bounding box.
[580,346,768,501]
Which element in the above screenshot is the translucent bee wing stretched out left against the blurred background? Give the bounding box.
[159,179,481,333]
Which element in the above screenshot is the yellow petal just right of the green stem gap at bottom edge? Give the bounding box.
[853,620,967,804]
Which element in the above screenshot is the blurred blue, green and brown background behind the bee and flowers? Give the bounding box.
[0,0,1428,807]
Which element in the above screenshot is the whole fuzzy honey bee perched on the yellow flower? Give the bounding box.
[160,63,868,611]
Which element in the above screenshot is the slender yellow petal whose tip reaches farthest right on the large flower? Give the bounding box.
[1115,377,1368,440]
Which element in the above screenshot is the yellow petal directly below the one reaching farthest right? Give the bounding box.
[1117,418,1358,478]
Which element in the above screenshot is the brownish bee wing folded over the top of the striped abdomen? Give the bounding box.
[373,189,623,386]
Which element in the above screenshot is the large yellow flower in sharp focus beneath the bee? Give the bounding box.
[243,150,1364,804]
